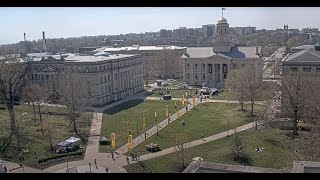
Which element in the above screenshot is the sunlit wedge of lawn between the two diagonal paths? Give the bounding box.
[132,103,265,154]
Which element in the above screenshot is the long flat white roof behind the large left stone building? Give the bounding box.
[104,45,183,52]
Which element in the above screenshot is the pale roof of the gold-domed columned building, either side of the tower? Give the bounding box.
[181,46,261,58]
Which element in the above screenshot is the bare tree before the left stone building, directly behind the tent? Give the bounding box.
[58,72,90,139]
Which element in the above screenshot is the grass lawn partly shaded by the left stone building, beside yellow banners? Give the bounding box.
[100,100,182,152]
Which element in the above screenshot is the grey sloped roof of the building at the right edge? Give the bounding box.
[282,50,320,64]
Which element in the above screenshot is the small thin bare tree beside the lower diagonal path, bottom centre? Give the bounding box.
[176,133,190,168]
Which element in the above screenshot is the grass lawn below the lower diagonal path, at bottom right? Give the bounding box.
[125,121,297,173]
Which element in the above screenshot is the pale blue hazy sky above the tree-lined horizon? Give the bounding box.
[0,7,320,44]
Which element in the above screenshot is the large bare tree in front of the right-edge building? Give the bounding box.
[280,73,319,136]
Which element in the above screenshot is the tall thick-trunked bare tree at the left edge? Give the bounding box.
[0,50,28,150]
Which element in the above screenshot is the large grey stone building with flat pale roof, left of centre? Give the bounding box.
[25,53,143,106]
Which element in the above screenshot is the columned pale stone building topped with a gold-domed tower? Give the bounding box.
[181,17,262,88]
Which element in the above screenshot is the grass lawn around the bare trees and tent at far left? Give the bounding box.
[0,105,92,168]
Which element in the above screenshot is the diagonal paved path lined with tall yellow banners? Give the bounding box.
[116,99,199,154]
